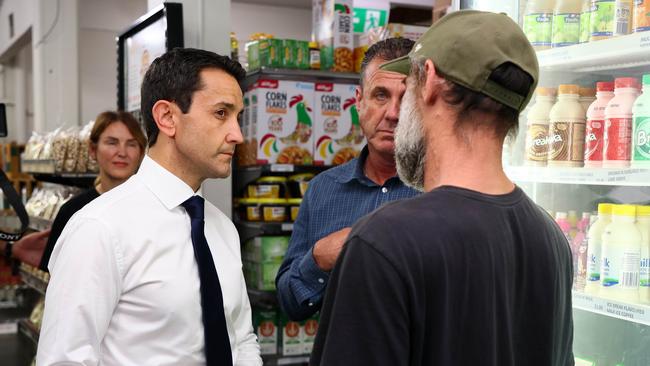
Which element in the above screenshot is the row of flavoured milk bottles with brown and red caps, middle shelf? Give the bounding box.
[525,74,650,168]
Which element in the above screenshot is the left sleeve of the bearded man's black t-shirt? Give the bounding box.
[311,236,409,366]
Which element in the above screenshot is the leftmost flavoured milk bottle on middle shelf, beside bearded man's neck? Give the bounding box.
[525,88,555,166]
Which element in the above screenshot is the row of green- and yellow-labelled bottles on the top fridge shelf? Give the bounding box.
[523,0,650,50]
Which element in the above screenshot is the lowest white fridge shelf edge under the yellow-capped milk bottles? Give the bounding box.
[573,291,650,326]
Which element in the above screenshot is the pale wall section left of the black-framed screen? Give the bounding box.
[79,0,147,123]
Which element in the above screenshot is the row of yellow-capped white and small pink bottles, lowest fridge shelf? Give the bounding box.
[556,203,650,304]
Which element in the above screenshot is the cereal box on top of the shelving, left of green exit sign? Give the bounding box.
[312,0,354,72]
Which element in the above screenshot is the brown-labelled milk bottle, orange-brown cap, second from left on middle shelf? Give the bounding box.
[548,84,585,167]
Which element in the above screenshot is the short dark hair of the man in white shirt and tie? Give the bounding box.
[140,48,246,147]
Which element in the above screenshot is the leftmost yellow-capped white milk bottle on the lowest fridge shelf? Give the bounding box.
[585,203,613,295]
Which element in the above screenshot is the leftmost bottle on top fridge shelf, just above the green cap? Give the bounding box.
[523,0,555,51]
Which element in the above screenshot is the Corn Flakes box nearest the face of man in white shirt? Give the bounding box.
[251,79,314,165]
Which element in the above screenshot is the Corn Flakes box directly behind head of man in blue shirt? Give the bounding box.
[314,83,366,165]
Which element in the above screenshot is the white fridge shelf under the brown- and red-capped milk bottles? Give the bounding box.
[505,166,650,186]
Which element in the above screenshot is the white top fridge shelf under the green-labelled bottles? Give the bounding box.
[537,32,650,72]
